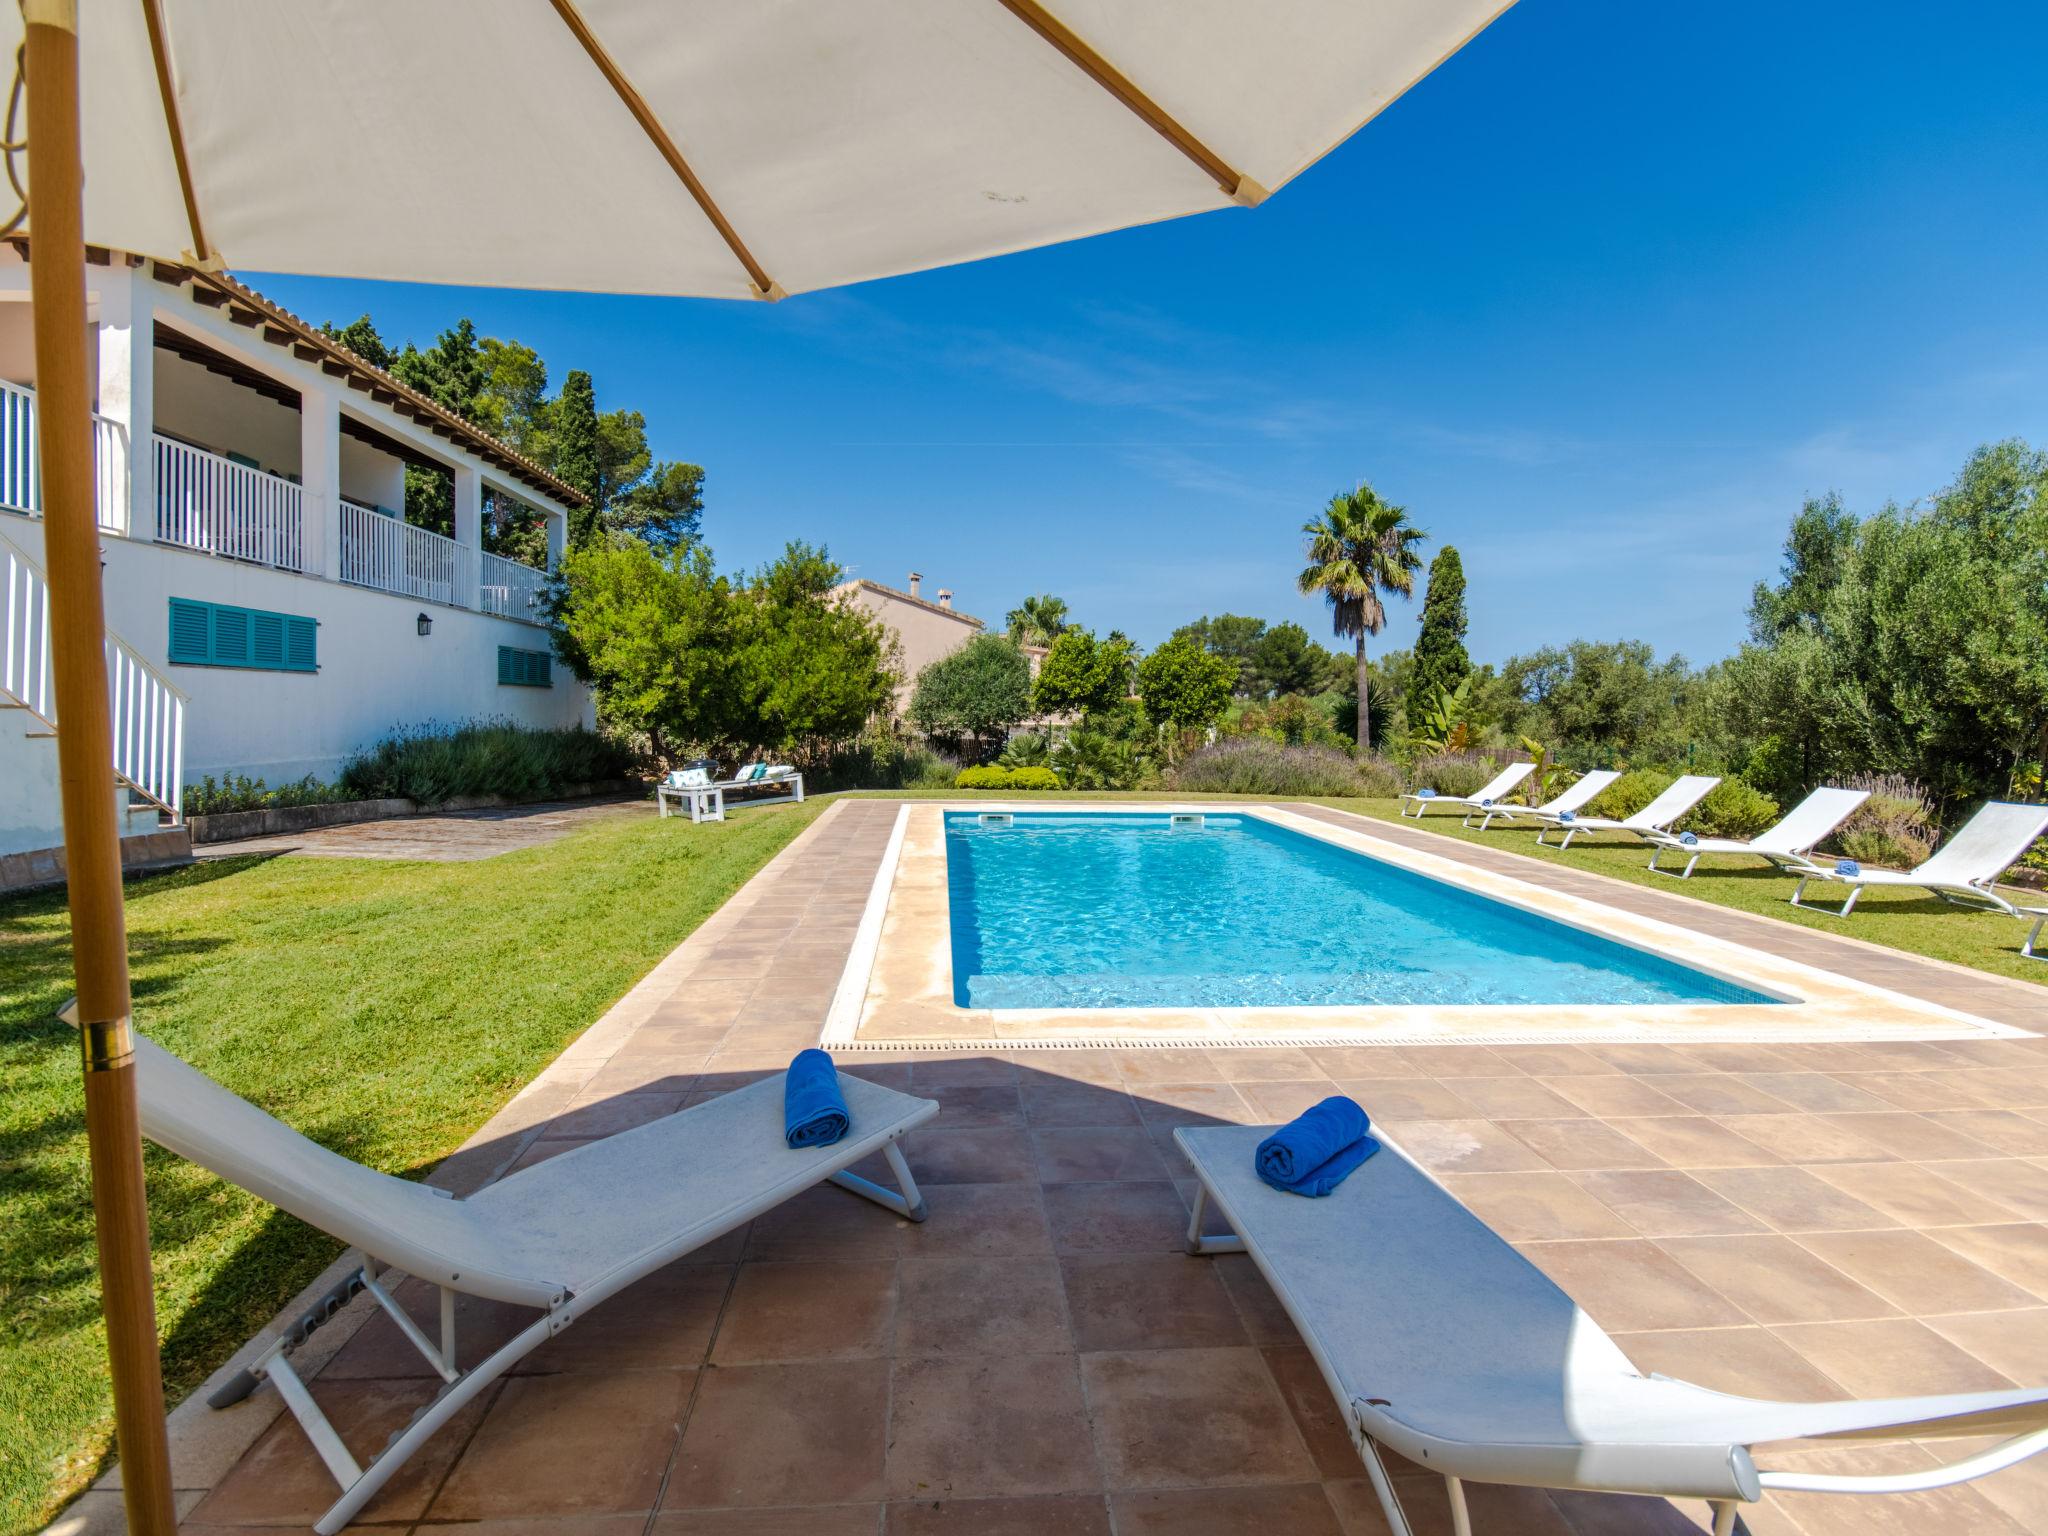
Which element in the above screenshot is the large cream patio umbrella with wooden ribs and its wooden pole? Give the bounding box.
[0,0,1511,1536]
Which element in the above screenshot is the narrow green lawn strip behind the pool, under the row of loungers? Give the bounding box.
[847,791,2048,987]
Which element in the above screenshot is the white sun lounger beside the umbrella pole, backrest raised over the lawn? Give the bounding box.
[135,1038,938,1536]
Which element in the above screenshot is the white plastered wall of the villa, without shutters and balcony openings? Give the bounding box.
[0,250,594,868]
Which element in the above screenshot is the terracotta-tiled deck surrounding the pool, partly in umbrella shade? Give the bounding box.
[78,801,2048,1536]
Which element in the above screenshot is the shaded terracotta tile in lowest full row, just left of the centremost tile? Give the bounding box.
[662,1360,889,1509]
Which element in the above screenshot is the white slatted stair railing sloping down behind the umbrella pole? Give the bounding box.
[0,535,186,827]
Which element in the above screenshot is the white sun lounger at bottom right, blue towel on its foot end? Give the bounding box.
[1174,1126,2048,1536]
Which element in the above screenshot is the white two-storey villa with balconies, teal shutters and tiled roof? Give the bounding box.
[0,240,592,876]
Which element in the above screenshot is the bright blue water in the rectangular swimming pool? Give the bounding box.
[946,811,1780,1008]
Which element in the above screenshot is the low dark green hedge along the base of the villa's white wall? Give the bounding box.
[336,721,633,805]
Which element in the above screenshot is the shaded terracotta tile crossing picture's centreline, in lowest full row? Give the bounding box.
[889,1354,1102,1501]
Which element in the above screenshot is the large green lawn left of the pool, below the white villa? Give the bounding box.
[0,801,825,1536]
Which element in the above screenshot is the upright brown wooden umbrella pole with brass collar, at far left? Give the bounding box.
[23,0,176,1536]
